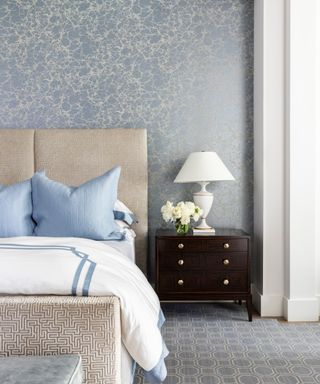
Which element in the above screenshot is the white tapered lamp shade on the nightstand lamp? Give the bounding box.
[174,152,234,183]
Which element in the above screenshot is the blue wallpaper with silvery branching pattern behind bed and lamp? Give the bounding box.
[0,0,253,274]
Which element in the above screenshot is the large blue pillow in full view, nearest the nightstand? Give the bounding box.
[31,167,123,240]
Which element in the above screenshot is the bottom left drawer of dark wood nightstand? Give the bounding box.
[159,272,202,292]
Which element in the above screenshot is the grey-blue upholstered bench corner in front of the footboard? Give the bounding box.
[0,355,82,384]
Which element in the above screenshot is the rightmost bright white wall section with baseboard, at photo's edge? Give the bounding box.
[284,0,319,321]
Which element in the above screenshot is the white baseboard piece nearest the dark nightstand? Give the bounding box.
[252,284,283,317]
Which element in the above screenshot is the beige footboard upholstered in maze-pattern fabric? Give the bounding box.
[0,296,121,384]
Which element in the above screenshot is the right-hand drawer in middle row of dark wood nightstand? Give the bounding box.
[202,252,248,272]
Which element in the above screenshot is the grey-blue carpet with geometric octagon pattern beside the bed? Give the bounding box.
[134,303,320,384]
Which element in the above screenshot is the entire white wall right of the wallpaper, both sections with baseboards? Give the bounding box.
[253,0,320,320]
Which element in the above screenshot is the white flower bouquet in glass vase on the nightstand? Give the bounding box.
[161,201,202,234]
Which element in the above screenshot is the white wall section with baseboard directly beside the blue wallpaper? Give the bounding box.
[253,0,285,316]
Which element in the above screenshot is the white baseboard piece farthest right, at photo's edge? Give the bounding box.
[284,297,319,321]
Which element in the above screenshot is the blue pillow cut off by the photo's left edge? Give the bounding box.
[0,180,34,237]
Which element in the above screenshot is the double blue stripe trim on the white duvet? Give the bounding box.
[0,243,96,296]
